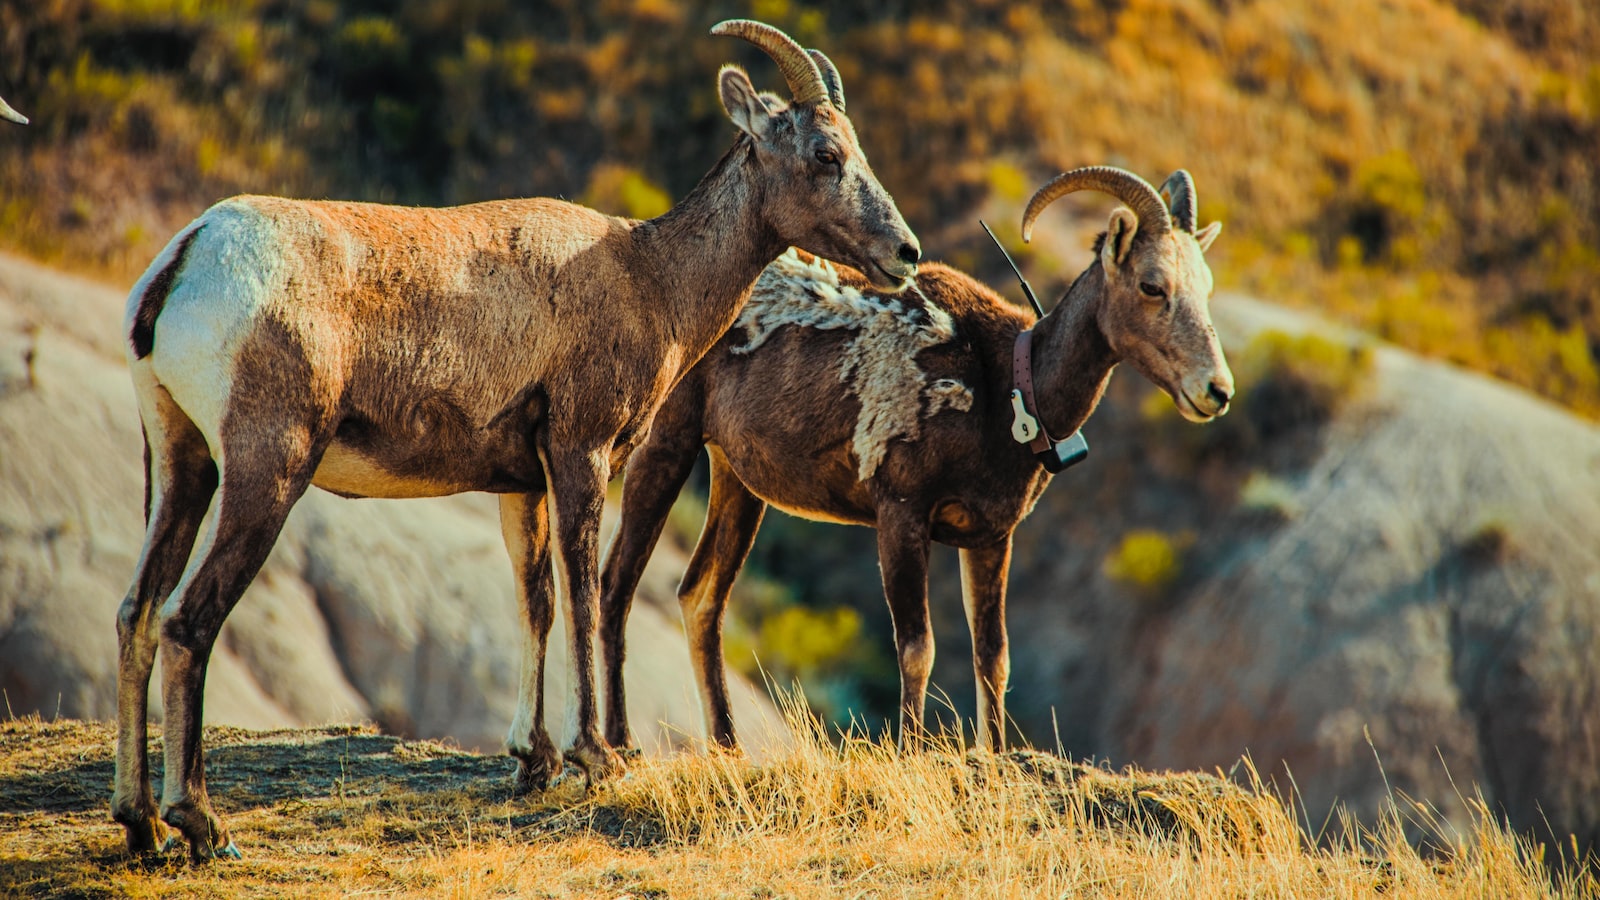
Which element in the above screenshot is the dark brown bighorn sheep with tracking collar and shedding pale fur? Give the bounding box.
[600,167,1234,748]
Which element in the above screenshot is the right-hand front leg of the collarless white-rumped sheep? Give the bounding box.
[544,450,624,783]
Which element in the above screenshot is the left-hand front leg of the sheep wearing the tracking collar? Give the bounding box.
[878,501,933,748]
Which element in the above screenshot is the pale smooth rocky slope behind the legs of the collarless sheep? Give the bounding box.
[0,249,776,749]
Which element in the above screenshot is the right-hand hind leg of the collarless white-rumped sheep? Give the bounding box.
[162,423,320,862]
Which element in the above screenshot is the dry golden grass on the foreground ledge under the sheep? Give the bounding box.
[0,701,1600,897]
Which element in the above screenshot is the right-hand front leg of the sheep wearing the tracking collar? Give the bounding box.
[962,535,1011,749]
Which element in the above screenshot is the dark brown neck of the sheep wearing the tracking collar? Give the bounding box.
[1034,259,1117,440]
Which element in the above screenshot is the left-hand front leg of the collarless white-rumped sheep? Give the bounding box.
[501,493,562,794]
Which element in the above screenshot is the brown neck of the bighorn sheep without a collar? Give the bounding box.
[634,138,786,365]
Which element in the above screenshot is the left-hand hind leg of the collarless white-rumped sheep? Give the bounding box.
[110,386,216,854]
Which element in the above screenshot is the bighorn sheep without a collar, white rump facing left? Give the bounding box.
[112,21,920,860]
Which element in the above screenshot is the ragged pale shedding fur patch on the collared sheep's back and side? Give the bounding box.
[733,250,973,480]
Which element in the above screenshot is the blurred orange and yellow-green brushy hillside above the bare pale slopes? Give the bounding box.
[0,0,1600,415]
